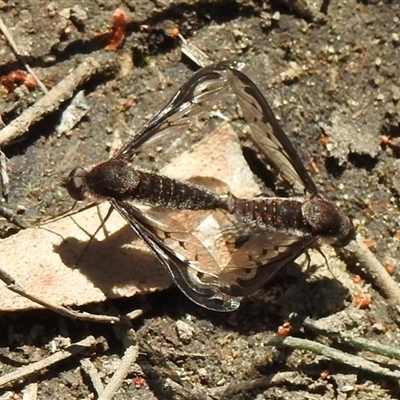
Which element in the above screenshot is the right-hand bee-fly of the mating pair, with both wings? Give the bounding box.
[211,67,355,296]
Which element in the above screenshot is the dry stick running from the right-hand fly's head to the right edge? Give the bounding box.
[346,234,400,311]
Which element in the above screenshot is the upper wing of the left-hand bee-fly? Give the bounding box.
[115,63,233,158]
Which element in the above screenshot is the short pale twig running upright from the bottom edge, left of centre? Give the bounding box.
[99,328,139,400]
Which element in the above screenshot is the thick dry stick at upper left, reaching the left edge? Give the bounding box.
[0,57,101,147]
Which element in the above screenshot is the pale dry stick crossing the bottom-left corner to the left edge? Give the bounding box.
[0,336,96,387]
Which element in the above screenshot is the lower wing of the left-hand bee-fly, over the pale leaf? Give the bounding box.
[110,199,240,312]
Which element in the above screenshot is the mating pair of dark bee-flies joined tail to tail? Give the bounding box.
[64,63,354,311]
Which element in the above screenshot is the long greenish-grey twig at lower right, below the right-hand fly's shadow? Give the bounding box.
[265,336,400,380]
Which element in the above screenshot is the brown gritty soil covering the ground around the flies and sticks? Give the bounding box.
[0,0,400,399]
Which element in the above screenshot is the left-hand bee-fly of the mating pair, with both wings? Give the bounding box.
[63,66,244,311]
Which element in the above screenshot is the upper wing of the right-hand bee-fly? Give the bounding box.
[227,68,317,195]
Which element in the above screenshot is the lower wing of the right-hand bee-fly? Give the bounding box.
[220,232,318,296]
